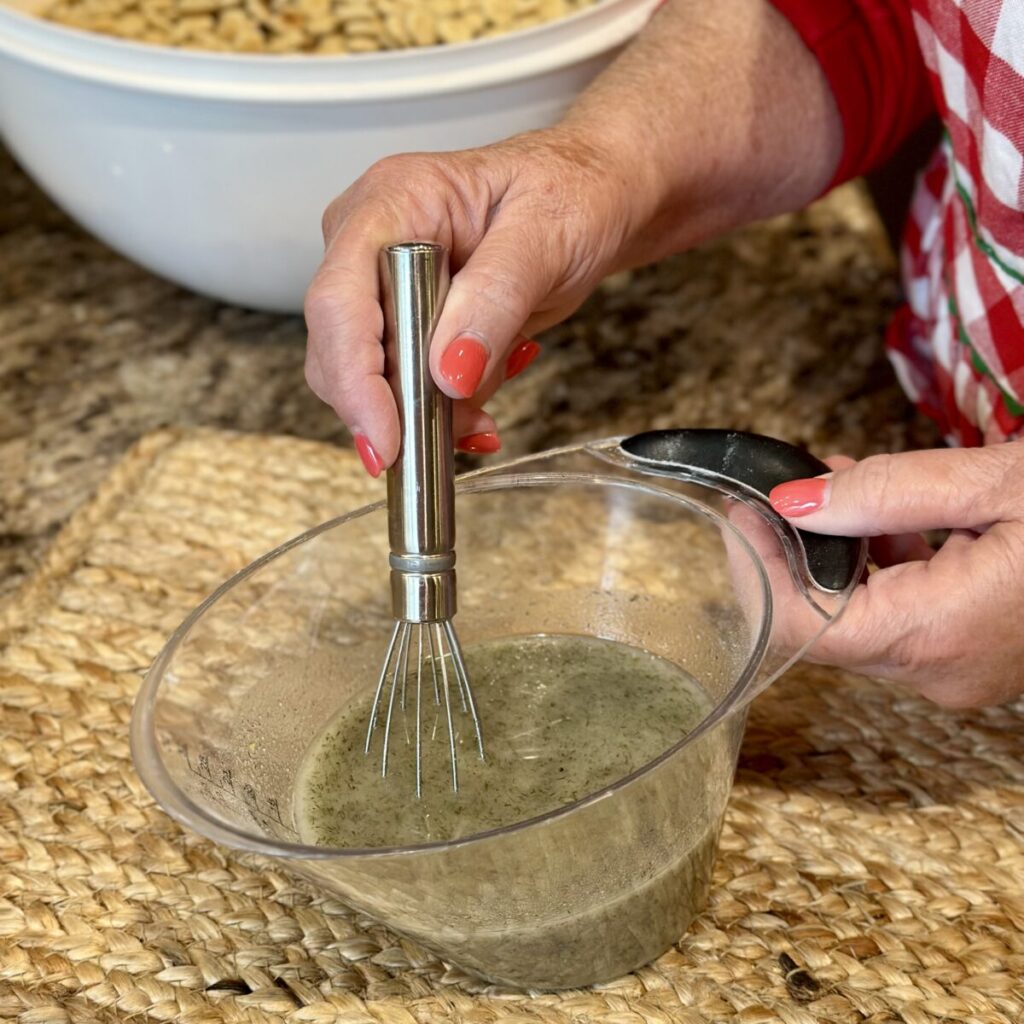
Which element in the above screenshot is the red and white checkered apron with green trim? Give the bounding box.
[889,0,1024,444]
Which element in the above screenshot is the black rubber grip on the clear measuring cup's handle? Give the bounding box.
[621,428,863,591]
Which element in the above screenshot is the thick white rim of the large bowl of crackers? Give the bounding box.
[0,0,658,104]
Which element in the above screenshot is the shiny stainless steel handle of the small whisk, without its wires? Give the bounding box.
[381,242,455,622]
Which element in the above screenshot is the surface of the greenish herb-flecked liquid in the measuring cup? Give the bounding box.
[298,636,711,848]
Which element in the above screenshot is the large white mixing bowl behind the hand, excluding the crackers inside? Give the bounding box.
[0,0,654,311]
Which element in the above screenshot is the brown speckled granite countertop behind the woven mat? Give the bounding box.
[0,139,937,595]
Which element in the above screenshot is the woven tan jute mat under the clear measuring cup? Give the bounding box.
[0,432,1024,1024]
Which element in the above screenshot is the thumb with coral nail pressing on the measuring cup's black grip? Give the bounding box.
[769,442,1024,537]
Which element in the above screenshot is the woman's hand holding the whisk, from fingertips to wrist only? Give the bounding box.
[305,128,637,476]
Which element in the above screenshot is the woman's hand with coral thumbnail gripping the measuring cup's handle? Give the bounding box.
[771,440,1024,707]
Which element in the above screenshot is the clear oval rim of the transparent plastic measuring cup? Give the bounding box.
[129,460,773,860]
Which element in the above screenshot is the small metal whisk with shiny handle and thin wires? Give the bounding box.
[366,242,483,797]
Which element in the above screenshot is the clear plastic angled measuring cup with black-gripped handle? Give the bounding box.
[131,431,865,988]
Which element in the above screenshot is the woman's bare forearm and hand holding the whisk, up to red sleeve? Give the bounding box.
[306,0,842,476]
